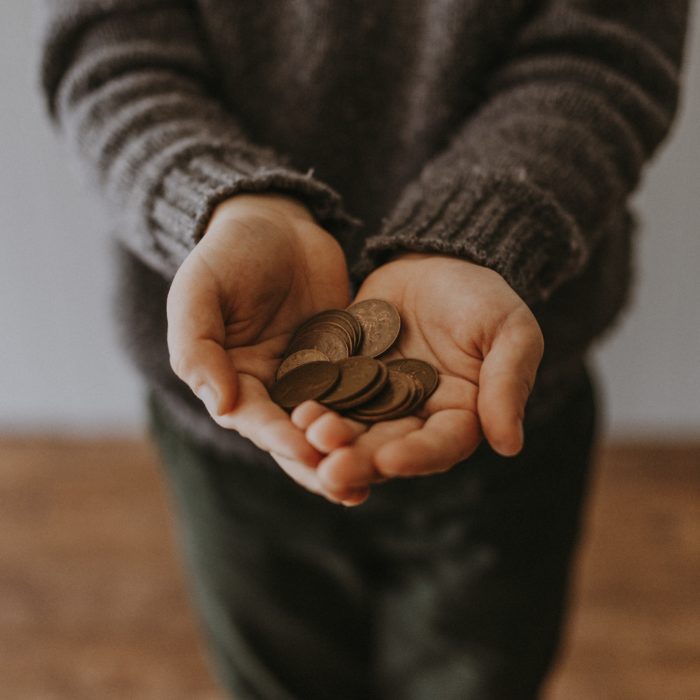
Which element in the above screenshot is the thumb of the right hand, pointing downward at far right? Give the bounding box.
[477,319,543,457]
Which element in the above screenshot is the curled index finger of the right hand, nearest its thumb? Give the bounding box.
[374,408,481,477]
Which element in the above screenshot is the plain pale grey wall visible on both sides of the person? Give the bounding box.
[0,2,700,436]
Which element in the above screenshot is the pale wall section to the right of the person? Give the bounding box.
[596,11,700,437]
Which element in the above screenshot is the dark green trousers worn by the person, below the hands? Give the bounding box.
[151,373,595,700]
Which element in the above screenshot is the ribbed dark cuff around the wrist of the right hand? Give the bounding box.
[353,169,587,304]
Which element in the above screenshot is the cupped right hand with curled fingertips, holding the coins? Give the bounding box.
[292,254,544,502]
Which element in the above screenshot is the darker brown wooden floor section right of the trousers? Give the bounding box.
[547,444,700,700]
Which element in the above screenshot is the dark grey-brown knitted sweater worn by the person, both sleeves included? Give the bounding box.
[42,0,687,448]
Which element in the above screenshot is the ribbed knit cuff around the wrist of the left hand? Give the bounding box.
[145,148,362,272]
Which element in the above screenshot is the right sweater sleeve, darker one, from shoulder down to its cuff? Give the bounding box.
[355,0,687,303]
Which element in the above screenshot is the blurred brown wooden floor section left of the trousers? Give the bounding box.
[0,440,223,700]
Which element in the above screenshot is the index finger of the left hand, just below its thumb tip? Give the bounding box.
[214,373,321,466]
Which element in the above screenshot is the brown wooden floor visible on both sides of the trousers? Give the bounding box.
[0,439,700,700]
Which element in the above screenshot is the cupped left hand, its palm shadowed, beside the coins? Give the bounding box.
[168,194,349,492]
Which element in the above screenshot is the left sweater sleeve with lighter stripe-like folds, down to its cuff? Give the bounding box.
[41,0,361,277]
